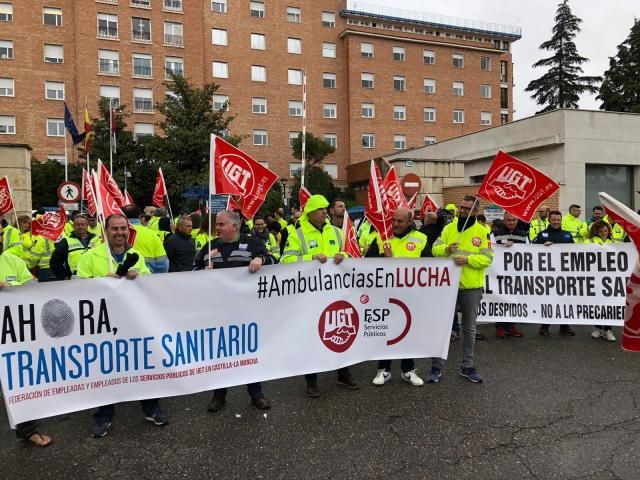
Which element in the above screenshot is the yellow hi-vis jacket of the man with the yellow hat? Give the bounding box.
[282,216,344,263]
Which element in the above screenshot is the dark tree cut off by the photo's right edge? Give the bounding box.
[596,20,640,113]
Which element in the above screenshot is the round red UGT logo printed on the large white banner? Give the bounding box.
[318,300,360,353]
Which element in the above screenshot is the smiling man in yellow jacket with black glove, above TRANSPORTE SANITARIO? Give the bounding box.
[78,214,169,438]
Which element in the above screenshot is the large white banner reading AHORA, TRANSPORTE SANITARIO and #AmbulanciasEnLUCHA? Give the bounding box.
[0,259,460,426]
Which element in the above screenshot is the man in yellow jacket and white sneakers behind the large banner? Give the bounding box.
[365,207,431,387]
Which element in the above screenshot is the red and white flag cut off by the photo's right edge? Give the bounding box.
[598,193,640,352]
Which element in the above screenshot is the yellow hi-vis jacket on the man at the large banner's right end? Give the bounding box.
[431,221,493,290]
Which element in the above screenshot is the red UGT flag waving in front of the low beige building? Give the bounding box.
[478,151,560,223]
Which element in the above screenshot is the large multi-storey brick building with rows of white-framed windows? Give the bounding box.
[0,0,520,185]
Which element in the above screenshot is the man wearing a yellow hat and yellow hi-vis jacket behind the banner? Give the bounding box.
[282,195,360,398]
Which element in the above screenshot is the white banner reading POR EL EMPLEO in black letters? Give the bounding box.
[478,243,637,326]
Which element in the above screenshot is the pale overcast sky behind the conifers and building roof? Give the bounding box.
[358,0,640,119]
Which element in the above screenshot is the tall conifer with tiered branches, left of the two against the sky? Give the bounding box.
[525,0,602,113]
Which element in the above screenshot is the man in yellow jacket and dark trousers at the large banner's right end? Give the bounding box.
[427,195,493,383]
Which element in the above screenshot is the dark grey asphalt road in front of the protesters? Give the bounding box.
[0,326,640,480]
